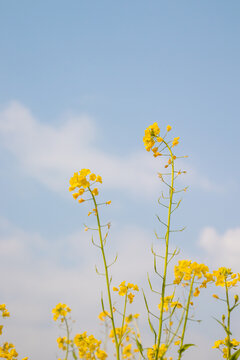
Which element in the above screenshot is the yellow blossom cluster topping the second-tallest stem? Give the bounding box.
[69,169,102,203]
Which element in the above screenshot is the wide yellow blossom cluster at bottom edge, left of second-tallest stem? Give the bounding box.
[73,331,107,360]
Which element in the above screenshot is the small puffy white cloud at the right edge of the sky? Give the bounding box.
[199,227,240,271]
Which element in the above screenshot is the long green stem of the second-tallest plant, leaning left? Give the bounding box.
[88,187,120,360]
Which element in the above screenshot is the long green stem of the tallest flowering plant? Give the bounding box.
[155,141,174,360]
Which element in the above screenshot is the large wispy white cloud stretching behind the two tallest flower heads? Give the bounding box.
[0,102,218,198]
